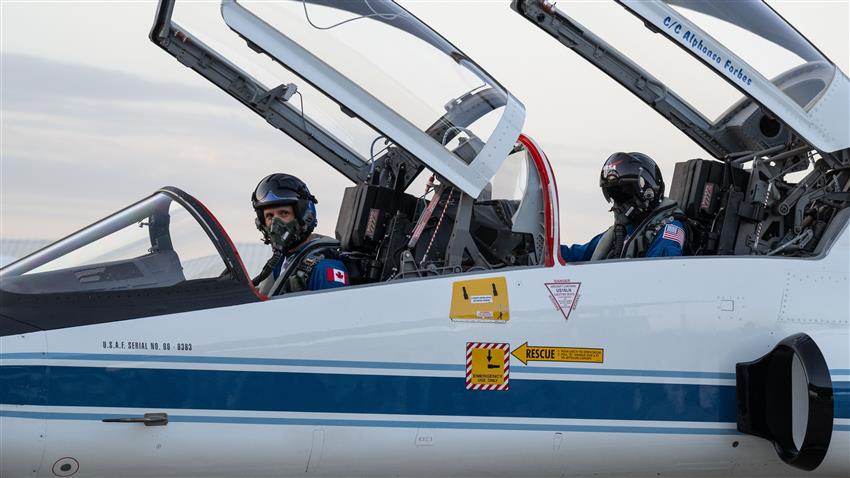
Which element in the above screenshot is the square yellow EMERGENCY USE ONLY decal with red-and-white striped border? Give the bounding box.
[466,342,511,390]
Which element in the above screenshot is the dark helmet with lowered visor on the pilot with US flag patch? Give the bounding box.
[599,152,664,217]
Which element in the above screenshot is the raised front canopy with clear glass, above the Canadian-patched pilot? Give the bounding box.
[151,0,525,197]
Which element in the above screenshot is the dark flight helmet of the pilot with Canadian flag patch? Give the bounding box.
[251,173,318,244]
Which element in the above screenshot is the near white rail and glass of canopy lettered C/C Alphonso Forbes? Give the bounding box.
[618,0,850,152]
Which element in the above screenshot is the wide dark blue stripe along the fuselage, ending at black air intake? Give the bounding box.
[0,366,735,422]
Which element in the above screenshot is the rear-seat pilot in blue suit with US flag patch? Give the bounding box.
[561,153,687,262]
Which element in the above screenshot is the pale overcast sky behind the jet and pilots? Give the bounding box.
[0,0,850,252]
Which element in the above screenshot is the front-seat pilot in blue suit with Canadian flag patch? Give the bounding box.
[251,173,348,295]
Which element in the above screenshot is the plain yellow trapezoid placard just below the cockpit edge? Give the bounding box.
[449,277,510,322]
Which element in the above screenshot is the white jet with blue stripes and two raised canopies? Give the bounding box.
[0,0,850,478]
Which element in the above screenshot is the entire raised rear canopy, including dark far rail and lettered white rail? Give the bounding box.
[512,0,850,159]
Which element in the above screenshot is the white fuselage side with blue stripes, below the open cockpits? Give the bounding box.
[0,228,850,478]
